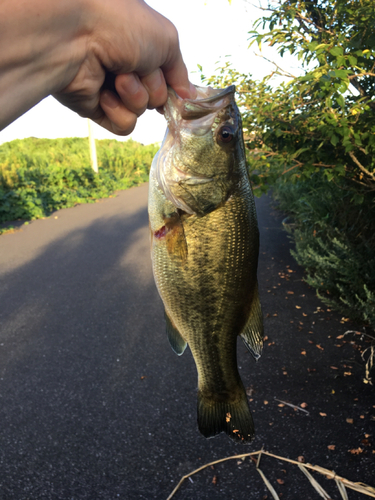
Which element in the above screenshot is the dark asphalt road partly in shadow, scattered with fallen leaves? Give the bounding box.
[0,185,375,500]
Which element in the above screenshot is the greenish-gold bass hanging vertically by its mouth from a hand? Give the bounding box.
[148,85,263,443]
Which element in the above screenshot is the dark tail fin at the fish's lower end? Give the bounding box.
[198,391,254,443]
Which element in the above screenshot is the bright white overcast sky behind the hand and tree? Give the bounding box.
[0,0,300,144]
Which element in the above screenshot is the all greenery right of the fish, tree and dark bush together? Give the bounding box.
[202,0,375,364]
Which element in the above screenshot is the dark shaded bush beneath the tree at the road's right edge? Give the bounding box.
[274,174,375,328]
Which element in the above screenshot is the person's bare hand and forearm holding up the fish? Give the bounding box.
[0,0,195,135]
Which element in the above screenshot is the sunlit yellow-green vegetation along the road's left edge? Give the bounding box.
[0,138,158,229]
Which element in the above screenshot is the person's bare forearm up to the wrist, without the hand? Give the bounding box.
[0,0,89,130]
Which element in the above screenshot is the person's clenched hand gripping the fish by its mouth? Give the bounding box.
[53,0,196,135]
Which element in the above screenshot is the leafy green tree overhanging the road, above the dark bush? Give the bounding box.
[204,0,375,199]
